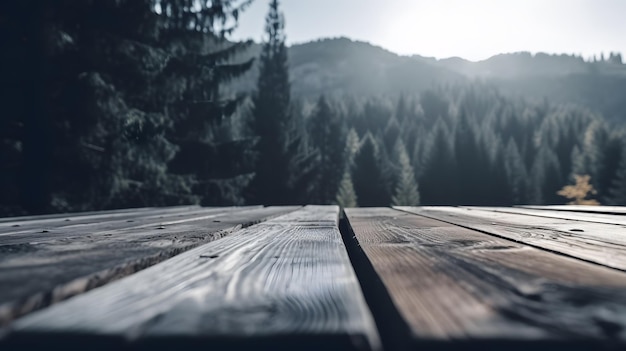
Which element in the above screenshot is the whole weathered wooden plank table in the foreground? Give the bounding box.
[0,206,626,351]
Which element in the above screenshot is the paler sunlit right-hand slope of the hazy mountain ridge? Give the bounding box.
[414,52,626,122]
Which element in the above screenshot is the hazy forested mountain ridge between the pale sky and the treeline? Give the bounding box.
[231,37,626,121]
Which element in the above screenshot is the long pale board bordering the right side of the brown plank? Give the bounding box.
[396,206,626,270]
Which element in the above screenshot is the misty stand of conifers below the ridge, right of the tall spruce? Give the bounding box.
[294,84,626,206]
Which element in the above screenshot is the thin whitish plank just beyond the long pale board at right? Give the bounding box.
[463,206,626,228]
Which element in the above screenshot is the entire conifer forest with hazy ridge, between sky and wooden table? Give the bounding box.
[0,0,626,216]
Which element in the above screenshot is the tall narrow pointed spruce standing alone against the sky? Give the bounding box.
[248,0,317,205]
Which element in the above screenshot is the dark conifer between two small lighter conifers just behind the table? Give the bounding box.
[352,133,391,207]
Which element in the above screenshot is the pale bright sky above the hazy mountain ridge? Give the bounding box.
[233,0,626,61]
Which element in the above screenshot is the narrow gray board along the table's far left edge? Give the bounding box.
[0,206,229,238]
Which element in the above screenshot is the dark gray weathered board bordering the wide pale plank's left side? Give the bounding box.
[0,206,297,325]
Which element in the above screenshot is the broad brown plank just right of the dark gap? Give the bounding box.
[346,208,626,350]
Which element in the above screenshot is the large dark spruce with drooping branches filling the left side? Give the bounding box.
[0,0,255,213]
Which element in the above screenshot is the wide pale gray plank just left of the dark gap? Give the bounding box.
[4,206,379,350]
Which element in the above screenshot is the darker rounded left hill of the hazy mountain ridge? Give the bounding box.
[224,38,467,98]
